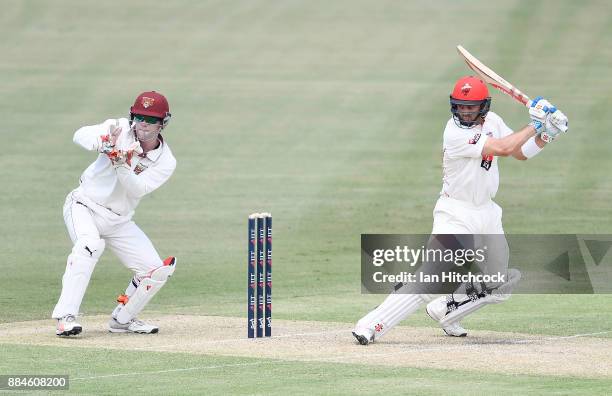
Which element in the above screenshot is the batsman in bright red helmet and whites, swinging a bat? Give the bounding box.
[353,76,568,345]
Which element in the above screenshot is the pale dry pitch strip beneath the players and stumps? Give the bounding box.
[0,315,612,378]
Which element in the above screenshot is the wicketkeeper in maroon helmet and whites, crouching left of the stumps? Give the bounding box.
[52,91,176,336]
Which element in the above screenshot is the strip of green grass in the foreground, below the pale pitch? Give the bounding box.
[0,345,612,395]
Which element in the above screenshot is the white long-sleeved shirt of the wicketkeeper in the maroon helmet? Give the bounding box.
[73,118,176,217]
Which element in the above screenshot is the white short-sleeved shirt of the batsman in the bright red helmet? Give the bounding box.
[440,111,513,206]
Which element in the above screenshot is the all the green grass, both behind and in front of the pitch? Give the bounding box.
[0,0,612,394]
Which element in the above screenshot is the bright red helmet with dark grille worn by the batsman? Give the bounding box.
[450,76,491,128]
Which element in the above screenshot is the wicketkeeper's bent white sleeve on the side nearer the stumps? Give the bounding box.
[115,158,176,198]
